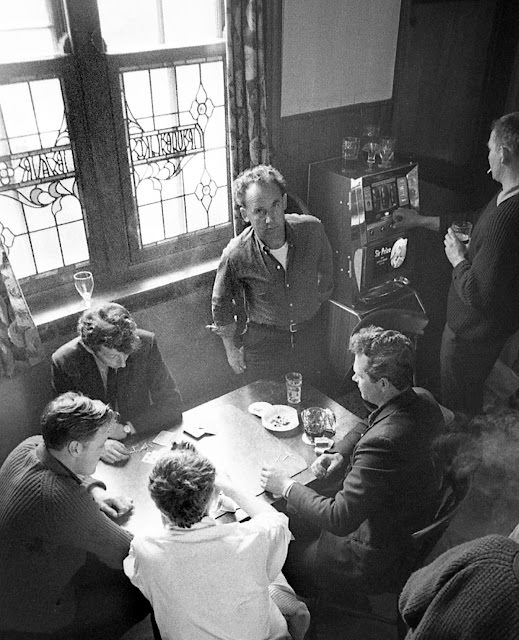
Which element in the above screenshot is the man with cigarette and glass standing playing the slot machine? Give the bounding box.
[393,112,519,416]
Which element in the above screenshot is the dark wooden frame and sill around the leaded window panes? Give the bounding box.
[0,0,233,308]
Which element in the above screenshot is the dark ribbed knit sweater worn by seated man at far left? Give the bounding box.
[0,436,131,635]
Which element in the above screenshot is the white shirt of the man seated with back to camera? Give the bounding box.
[124,512,290,640]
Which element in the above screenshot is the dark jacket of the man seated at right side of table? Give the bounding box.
[287,389,443,593]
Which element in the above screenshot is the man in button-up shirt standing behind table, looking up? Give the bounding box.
[212,165,333,382]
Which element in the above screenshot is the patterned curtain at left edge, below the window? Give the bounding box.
[0,237,44,378]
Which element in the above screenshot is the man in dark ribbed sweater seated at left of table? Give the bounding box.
[0,392,150,640]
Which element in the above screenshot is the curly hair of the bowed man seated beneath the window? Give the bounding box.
[77,302,141,355]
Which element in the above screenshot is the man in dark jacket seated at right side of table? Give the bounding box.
[261,327,443,601]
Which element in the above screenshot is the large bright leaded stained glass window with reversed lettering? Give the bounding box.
[0,0,232,292]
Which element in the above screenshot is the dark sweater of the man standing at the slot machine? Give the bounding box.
[441,194,519,342]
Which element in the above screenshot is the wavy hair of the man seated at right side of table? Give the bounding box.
[349,326,415,391]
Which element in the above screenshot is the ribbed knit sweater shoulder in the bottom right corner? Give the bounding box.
[399,535,519,640]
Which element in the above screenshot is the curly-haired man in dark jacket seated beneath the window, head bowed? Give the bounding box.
[51,302,182,463]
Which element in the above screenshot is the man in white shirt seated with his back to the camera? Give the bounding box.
[124,442,310,640]
